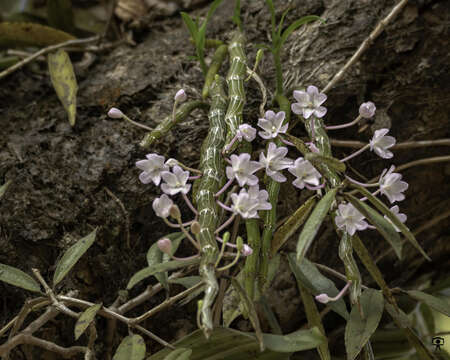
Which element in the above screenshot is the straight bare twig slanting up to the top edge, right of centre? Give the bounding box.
[322,0,408,93]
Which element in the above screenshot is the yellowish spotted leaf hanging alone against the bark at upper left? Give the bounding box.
[48,49,78,126]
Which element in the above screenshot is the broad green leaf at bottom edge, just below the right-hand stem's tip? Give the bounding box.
[345,289,384,360]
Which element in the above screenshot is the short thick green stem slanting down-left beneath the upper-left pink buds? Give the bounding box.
[139,101,208,149]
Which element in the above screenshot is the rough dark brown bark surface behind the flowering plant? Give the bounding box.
[0,0,450,359]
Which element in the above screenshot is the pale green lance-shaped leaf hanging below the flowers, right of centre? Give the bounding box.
[297,188,338,262]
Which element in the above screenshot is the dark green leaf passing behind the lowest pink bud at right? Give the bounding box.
[288,253,349,319]
